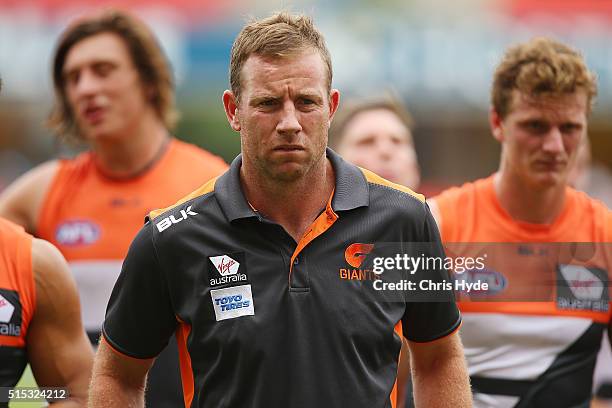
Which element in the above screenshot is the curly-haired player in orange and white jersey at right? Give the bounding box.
[431,39,612,407]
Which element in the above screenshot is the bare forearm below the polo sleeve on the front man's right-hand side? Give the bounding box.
[408,333,472,408]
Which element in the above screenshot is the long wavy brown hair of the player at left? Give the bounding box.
[48,9,178,142]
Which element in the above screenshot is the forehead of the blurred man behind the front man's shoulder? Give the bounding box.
[344,108,412,141]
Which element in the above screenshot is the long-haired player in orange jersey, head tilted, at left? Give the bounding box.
[0,10,227,407]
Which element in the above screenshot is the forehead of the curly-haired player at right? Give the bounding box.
[509,90,588,120]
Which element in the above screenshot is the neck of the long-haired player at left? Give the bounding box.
[91,114,169,179]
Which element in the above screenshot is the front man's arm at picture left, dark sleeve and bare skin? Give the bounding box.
[89,223,177,408]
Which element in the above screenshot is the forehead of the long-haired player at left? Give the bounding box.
[63,32,133,73]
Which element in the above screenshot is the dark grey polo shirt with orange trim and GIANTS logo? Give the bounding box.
[103,149,460,408]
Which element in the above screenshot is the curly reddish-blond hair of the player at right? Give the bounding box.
[491,37,597,118]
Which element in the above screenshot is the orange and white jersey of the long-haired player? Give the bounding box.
[36,139,227,332]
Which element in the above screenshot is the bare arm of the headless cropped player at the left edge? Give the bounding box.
[26,239,93,408]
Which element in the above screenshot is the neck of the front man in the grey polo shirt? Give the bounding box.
[240,157,335,242]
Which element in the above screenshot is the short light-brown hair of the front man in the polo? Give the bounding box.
[229,12,332,100]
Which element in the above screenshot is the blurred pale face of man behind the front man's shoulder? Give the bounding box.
[338,108,420,189]
